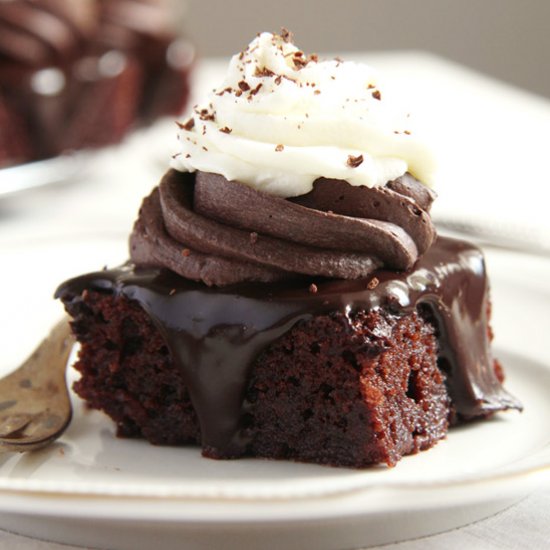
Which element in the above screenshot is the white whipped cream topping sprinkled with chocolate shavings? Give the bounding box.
[172,33,434,197]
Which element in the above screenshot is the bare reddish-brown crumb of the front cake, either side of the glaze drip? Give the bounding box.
[66,291,449,468]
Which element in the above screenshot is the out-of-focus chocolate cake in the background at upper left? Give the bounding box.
[0,0,193,166]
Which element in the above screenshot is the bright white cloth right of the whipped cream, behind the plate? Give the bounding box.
[368,52,550,253]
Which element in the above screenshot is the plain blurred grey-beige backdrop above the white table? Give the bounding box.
[181,0,550,97]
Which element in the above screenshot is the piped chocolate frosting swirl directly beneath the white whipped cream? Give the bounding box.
[130,170,435,286]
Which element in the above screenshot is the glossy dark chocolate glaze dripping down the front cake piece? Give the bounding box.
[56,238,521,456]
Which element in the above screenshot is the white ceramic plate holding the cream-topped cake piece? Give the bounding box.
[0,241,550,548]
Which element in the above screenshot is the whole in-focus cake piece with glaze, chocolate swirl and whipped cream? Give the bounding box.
[56,34,521,468]
